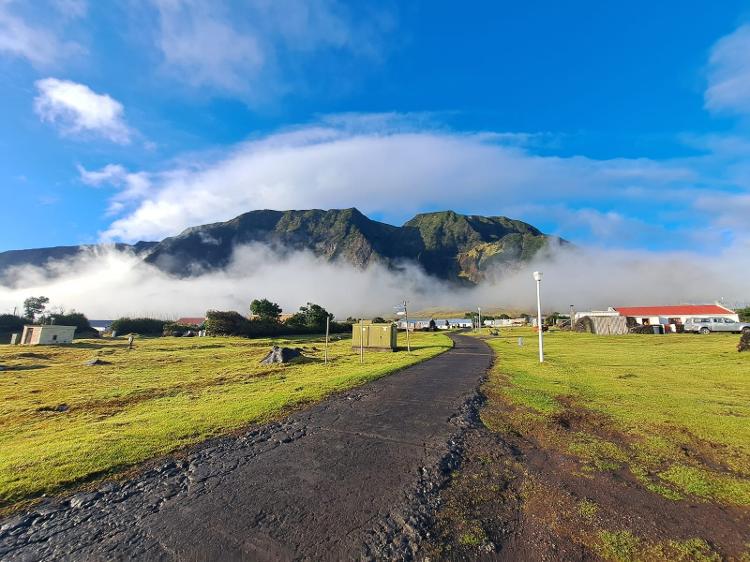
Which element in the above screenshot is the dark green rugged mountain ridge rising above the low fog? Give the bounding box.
[0,208,565,284]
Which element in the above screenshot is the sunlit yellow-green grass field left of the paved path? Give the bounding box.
[0,333,451,508]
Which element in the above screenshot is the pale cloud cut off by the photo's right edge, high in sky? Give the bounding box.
[705,24,750,114]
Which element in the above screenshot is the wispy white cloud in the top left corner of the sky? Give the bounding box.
[0,0,82,68]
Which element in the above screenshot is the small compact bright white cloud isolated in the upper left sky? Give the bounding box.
[34,78,133,144]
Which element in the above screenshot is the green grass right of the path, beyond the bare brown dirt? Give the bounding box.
[483,329,750,505]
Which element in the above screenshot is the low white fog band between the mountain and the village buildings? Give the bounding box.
[0,244,750,318]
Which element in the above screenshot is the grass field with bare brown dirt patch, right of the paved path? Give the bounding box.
[464,329,750,562]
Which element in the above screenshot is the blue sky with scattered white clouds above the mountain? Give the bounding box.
[0,0,750,249]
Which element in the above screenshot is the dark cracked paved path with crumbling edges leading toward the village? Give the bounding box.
[0,335,492,560]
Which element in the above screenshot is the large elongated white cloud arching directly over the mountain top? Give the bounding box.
[98,119,696,244]
